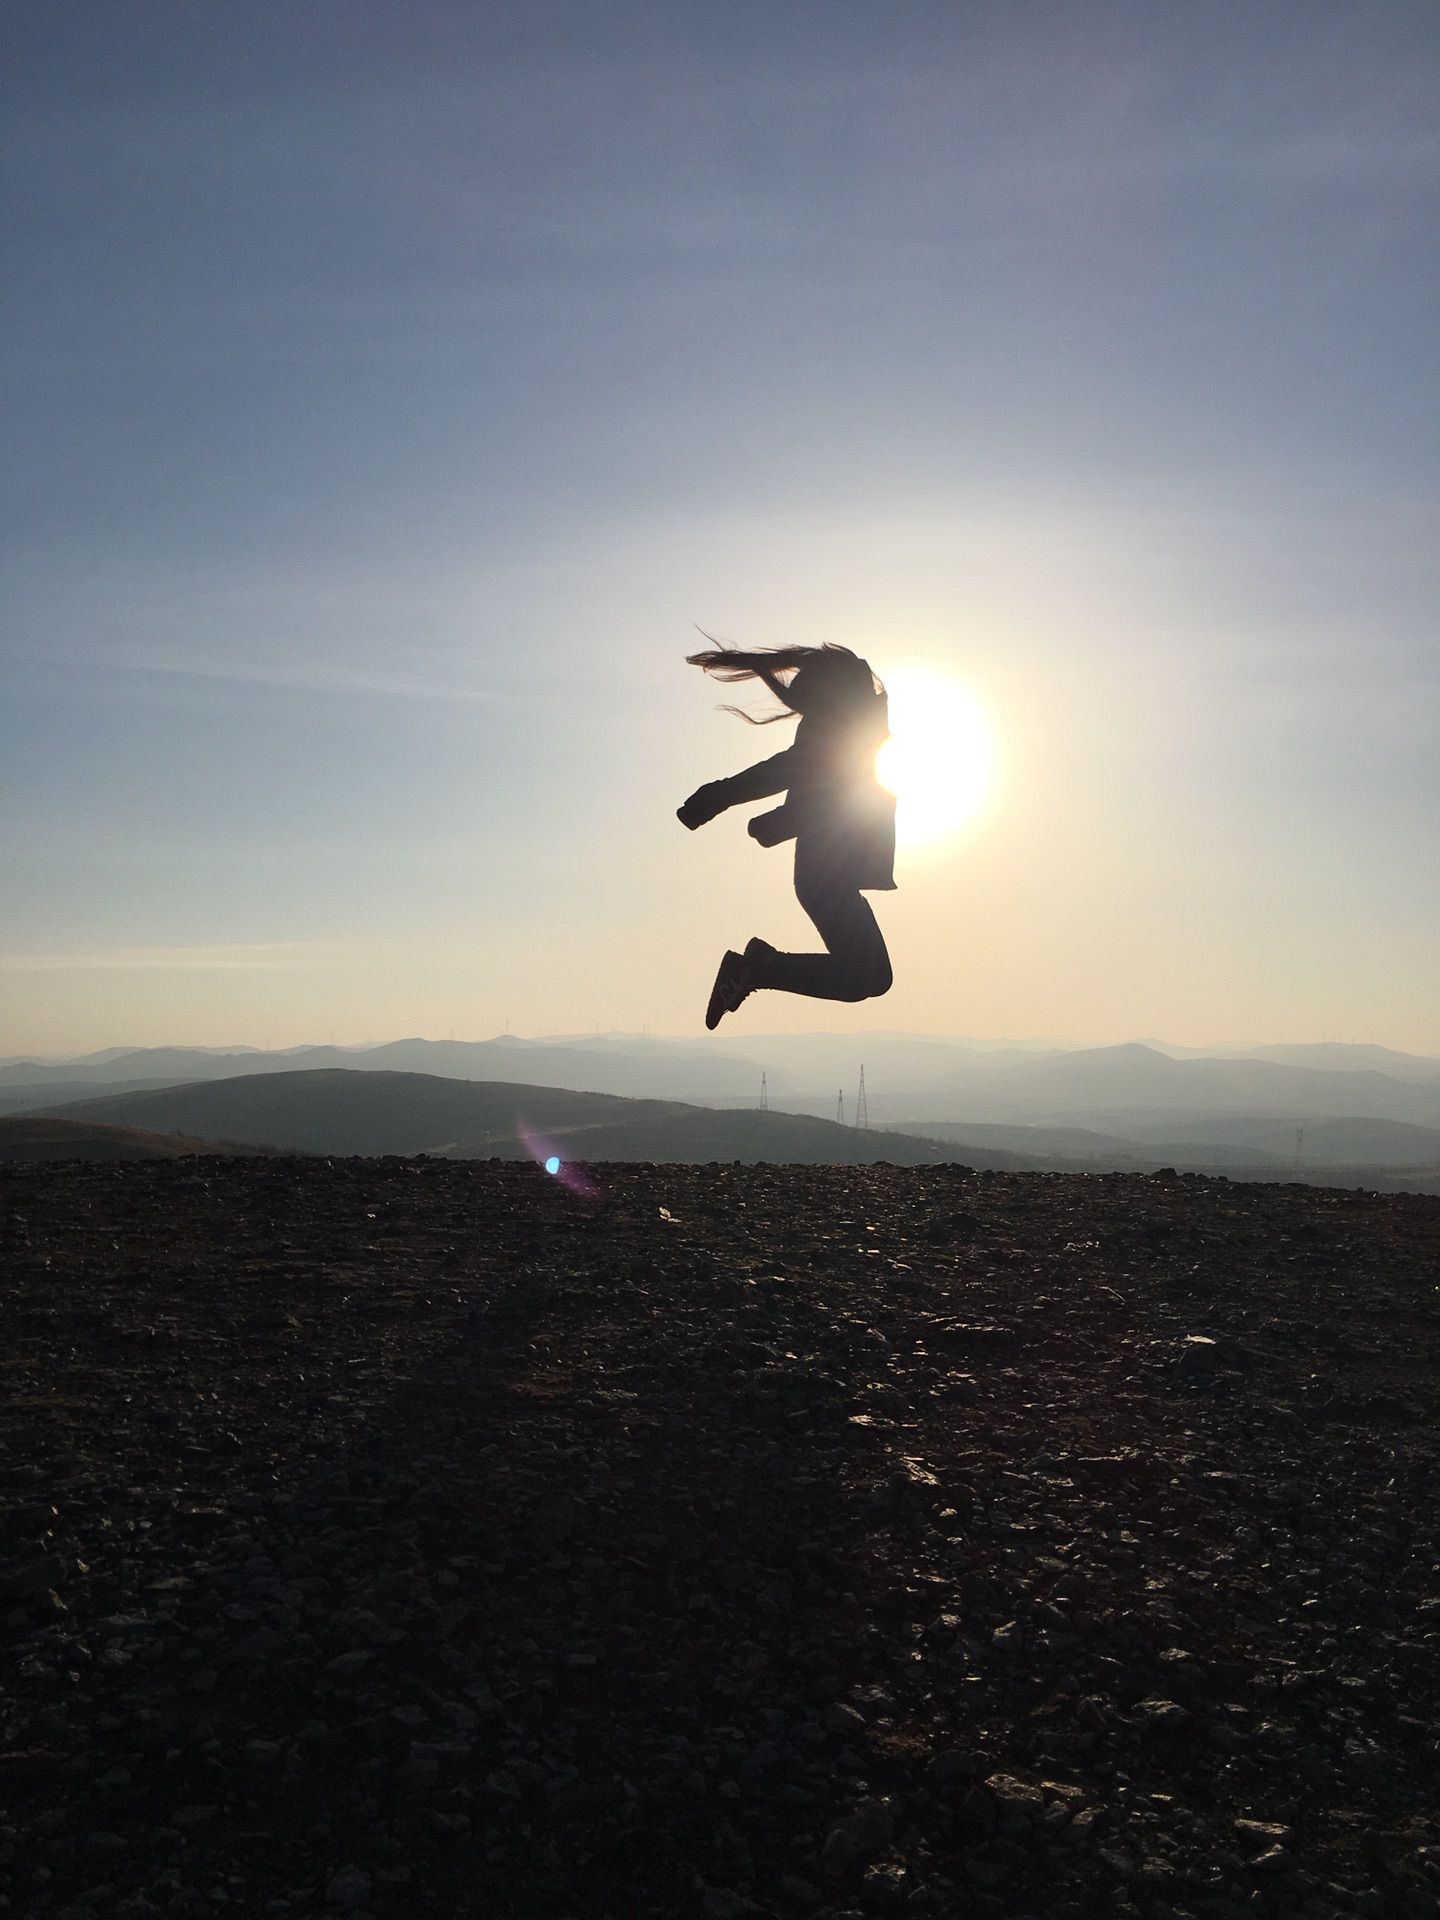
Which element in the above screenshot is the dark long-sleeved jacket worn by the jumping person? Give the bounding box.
[680,707,895,891]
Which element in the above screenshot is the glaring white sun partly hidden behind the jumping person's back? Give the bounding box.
[876,670,996,847]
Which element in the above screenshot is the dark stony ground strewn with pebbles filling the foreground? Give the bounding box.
[0,1160,1440,1920]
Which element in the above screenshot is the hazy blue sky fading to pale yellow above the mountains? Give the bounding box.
[0,0,1440,1052]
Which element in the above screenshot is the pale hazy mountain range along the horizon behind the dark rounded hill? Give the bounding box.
[0,1033,1440,1171]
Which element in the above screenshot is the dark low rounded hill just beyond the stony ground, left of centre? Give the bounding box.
[28,1069,950,1165]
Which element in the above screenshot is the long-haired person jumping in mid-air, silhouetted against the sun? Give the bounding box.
[676,645,895,1031]
